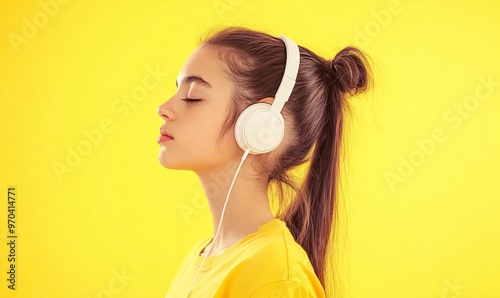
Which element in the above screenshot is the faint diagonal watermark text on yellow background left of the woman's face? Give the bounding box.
[52,65,168,182]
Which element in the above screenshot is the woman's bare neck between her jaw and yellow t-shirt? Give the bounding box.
[197,156,274,255]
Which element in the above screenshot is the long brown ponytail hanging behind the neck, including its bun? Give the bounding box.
[282,47,369,287]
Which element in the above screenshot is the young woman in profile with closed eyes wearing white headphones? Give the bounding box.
[158,27,369,298]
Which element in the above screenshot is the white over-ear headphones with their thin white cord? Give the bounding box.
[186,36,300,297]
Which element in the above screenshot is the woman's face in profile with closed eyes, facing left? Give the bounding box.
[158,46,243,173]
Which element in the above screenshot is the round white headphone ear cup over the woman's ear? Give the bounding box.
[234,103,285,154]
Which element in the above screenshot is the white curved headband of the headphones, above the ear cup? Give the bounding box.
[271,36,300,114]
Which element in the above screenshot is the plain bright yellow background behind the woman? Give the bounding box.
[0,0,500,298]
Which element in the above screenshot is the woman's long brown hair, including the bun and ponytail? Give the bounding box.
[201,27,371,294]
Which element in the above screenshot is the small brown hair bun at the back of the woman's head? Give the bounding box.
[328,46,369,96]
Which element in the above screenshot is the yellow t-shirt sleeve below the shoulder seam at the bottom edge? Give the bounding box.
[250,281,323,298]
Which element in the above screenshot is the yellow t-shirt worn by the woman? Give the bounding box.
[166,219,325,298]
